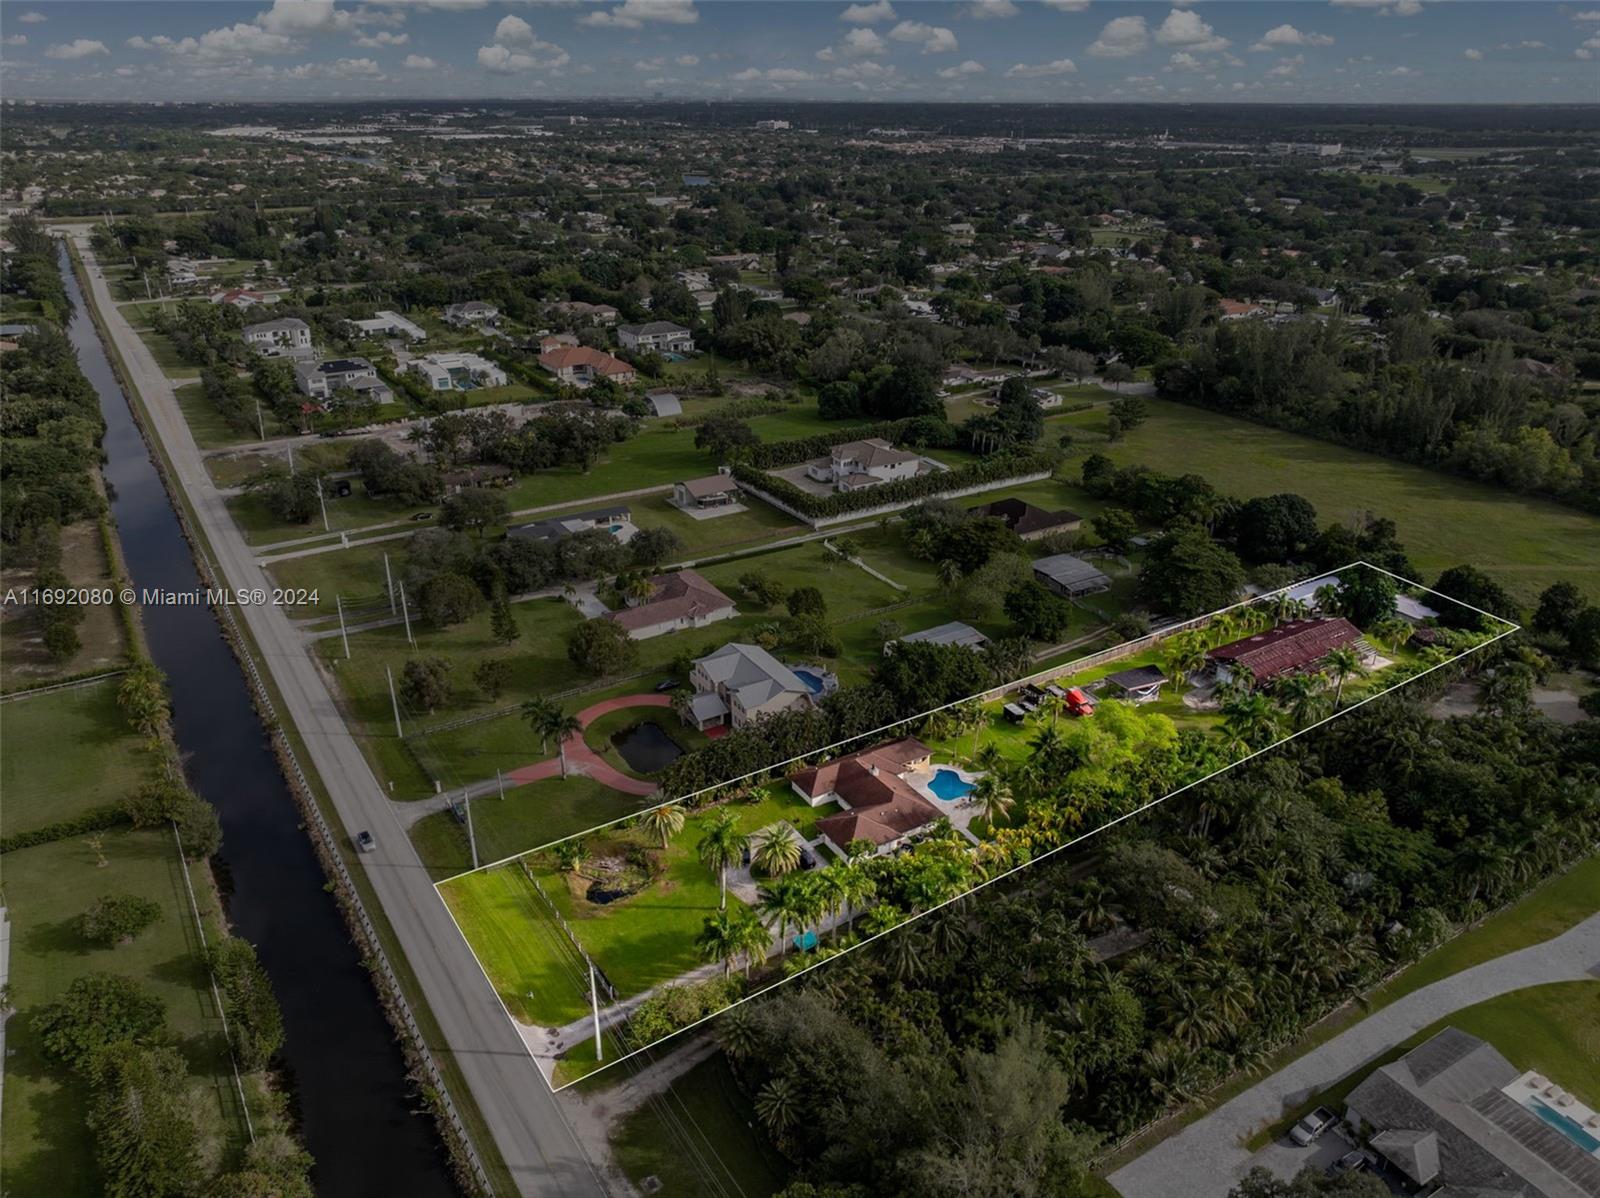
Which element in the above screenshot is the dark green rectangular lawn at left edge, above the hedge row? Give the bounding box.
[0,678,149,835]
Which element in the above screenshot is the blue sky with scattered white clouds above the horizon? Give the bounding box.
[0,0,1600,104]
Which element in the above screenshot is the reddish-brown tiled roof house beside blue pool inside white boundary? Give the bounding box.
[789,736,944,856]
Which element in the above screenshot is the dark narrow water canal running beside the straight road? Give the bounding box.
[61,248,456,1198]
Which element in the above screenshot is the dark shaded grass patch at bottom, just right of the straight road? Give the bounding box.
[611,1056,789,1198]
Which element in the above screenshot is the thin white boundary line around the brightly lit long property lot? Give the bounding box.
[434,560,1522,1094]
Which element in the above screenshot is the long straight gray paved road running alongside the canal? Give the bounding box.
[65,229,606,1198]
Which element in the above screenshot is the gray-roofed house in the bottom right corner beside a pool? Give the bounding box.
[1346,1027,1600,1198]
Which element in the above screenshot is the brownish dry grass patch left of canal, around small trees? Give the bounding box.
[0,520,126,691]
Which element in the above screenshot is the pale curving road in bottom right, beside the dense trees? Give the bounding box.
[1110,915,1600,1198]
